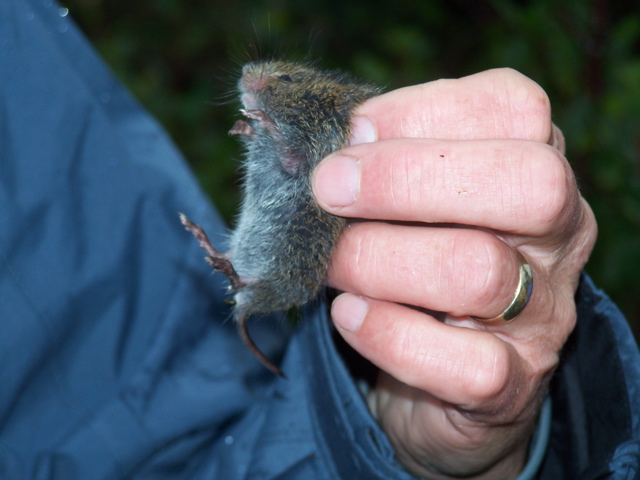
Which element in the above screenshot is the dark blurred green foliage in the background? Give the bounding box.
[64,0,640,332]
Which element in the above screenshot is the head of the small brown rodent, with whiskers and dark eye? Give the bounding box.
[239,61,379,171]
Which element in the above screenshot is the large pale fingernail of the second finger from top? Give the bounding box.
[313,155,360,207]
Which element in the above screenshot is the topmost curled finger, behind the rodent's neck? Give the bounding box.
[352,68,552,144]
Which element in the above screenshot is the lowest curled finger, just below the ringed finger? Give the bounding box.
[331,294,523,410]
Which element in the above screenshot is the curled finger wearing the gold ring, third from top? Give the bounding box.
[328,222,519,318]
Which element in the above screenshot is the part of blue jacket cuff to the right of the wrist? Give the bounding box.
[538,275,640,480]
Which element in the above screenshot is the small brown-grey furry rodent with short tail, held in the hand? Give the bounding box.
[180,61,380,376]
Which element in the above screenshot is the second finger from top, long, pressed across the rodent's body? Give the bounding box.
[312,139,579,236]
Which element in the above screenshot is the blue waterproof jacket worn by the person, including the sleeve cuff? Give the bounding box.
[0,0,640,480]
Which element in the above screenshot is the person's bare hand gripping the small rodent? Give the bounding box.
[312,69,597,479]
